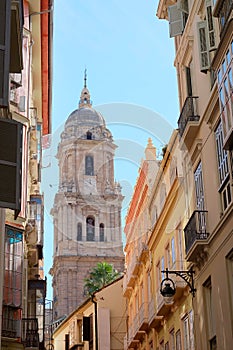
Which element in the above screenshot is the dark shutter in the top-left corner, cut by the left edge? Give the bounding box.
[0,0,11,107]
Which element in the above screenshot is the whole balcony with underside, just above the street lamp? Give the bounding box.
[184,210,209,262]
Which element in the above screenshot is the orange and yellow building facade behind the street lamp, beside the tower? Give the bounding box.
[123,131,195,350]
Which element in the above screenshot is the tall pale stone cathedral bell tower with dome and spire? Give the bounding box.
[51,72,124,319]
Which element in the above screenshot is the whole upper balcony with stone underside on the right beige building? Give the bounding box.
[178,96,200,148]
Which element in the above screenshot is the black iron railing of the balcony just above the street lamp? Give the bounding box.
[184,210,209,254]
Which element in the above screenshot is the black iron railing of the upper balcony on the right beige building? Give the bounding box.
[178,96,200,136]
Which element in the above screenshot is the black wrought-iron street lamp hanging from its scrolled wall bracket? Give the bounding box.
[160,268,196,304]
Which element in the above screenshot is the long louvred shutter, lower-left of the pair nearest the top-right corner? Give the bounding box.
[197,21,210,72]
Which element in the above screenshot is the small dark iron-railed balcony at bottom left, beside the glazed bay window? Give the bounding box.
[22,318,39,349]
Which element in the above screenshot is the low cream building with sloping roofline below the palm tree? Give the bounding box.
[53,277,127,350]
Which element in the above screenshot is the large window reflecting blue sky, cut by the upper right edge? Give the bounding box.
[217,42,233,149]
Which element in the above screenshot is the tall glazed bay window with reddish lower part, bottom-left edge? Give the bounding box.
[2,226,23,338]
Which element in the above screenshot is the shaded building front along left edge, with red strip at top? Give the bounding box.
[0,0,53,349]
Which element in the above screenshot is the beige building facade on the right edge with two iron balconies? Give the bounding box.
[157,0,233,350]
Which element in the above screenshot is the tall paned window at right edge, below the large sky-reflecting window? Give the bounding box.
[215,122,232,211]
